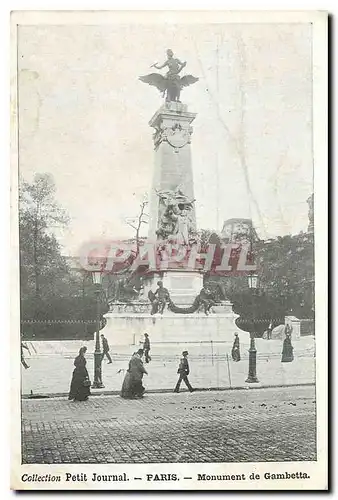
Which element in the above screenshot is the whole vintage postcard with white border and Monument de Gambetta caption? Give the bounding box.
[11,11,328,491]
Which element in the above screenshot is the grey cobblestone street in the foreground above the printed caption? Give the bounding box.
[22,386,316,464]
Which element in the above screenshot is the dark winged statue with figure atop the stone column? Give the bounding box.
[139,49,198,102]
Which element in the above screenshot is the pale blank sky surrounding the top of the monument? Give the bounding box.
[18,22,313,255]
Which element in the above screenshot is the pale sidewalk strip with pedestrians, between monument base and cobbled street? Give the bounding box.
[22,337,315,396]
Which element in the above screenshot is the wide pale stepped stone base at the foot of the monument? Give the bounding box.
[103,303,240,346]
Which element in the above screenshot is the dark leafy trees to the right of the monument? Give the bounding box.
[229,233,314,336]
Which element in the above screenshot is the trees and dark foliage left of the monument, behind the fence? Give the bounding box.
[19,174,108,339]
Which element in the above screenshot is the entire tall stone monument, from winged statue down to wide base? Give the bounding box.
[104,49,237,345]
